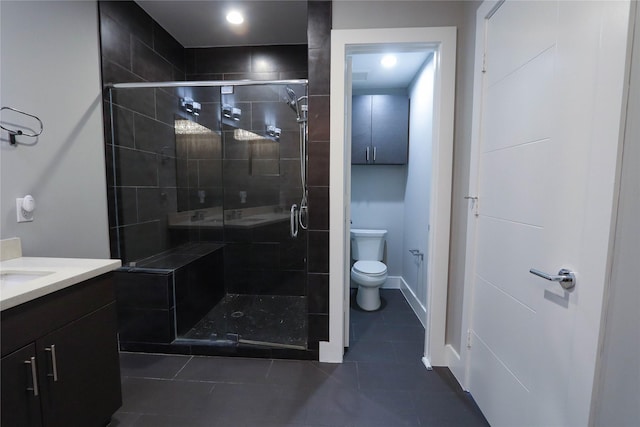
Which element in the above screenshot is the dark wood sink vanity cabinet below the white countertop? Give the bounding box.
[0,273,122,427]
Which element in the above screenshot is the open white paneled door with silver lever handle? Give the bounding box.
[467,1,629,427]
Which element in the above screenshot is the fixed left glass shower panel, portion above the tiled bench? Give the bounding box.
[107,87,223,265]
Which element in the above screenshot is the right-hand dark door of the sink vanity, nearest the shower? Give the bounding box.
[37,303,122,427]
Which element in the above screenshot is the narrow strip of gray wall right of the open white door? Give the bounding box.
[592,3,640,427]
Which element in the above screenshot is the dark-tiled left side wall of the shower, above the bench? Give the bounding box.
[99,1,185,263]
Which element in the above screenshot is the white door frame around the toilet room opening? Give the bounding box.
[320,27,456,367]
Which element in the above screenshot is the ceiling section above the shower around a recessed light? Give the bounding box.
[136,0,307,47]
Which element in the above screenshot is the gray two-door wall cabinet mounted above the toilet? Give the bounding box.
[351,95,409,165]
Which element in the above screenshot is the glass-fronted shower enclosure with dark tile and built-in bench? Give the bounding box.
[106,80,308,354]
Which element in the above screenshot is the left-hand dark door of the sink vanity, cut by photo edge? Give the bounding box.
[0,344,42,427]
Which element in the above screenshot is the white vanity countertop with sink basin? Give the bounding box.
[0,257,122,310]
